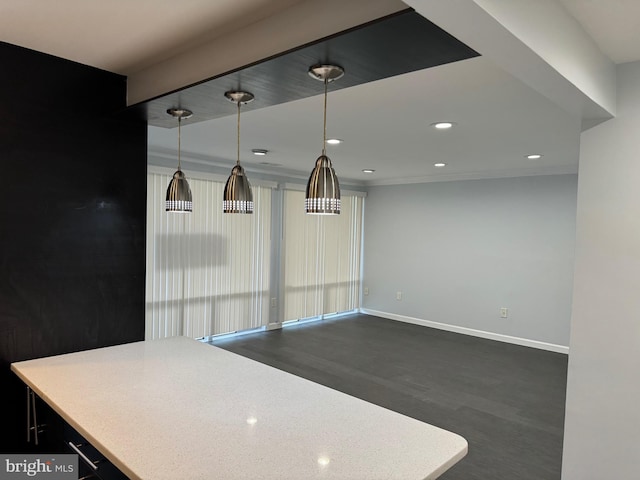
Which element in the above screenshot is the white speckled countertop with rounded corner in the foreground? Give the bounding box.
[11,337,467,480]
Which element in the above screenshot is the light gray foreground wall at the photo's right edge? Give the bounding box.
[562,62,640,480]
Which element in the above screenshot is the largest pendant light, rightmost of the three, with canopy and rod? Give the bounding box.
[304,65,344,215]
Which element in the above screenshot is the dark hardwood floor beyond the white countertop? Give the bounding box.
[211,314,567,480]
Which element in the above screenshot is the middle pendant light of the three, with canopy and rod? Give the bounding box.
[222,92,253,213]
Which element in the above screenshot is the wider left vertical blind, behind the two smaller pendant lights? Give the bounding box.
[145,172,271,339]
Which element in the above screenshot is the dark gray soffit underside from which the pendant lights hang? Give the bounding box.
[127,9,479,128]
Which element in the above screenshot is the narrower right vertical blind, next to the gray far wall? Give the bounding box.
[283,190,363,321]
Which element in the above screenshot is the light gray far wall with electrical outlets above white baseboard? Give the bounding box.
[363,175,577,346]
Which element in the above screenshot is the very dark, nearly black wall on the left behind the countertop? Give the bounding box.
[0,43,147,452]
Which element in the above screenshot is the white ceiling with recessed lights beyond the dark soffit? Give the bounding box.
[149,57,580,184]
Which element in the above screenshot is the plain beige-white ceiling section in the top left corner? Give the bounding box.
[0,0,300,75]
